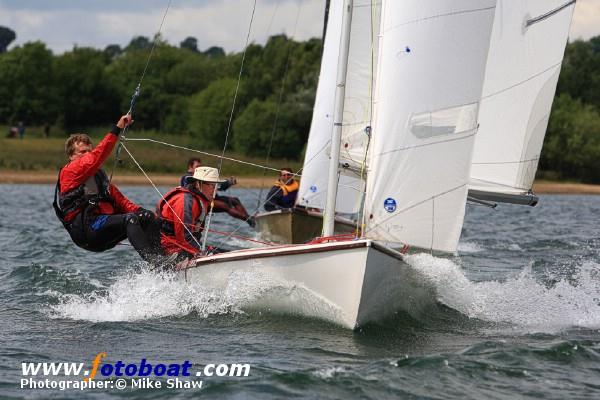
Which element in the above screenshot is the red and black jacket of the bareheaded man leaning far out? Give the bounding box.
[55,133,140,226]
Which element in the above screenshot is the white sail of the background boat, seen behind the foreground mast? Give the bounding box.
[298,0,381,213]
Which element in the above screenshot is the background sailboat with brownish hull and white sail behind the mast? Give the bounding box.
[256,0,368,244]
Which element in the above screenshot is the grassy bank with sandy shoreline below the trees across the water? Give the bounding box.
[0,126,600,194]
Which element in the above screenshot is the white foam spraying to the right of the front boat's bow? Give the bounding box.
[400,254,600,332]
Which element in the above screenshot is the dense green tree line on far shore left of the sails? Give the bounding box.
[0,29,322,159]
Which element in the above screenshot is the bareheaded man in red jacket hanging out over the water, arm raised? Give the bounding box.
[53,115,158,261]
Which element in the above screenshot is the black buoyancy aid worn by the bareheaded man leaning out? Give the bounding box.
[52,169,113,230]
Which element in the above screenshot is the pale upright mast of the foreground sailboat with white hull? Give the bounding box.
[323,0,353,236]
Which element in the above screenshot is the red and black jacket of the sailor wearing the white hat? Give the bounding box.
[156,187,210,255]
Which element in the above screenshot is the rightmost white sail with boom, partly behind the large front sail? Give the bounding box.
[469,0,575,202]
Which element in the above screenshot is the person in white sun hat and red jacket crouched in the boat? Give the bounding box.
[157,167,224,260]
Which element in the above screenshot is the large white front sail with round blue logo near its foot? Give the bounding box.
[365,0,496,252]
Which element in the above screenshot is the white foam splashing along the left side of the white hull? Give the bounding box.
[50,264,342,322]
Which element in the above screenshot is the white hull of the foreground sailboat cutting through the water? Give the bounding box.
[181,240,435,329]
